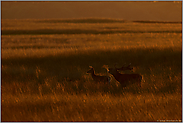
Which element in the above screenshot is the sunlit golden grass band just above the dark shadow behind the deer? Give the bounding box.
[2,33,182,59]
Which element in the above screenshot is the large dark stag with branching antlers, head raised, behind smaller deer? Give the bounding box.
[103,65,142,87]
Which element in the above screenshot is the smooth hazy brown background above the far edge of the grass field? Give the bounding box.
[1,2,182,21]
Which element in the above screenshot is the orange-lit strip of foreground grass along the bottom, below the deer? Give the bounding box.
[2,93,182,121]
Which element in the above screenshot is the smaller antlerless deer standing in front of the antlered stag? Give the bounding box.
[87,66,111,84]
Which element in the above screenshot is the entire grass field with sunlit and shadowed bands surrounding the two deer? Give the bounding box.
[1,19,182,121]
